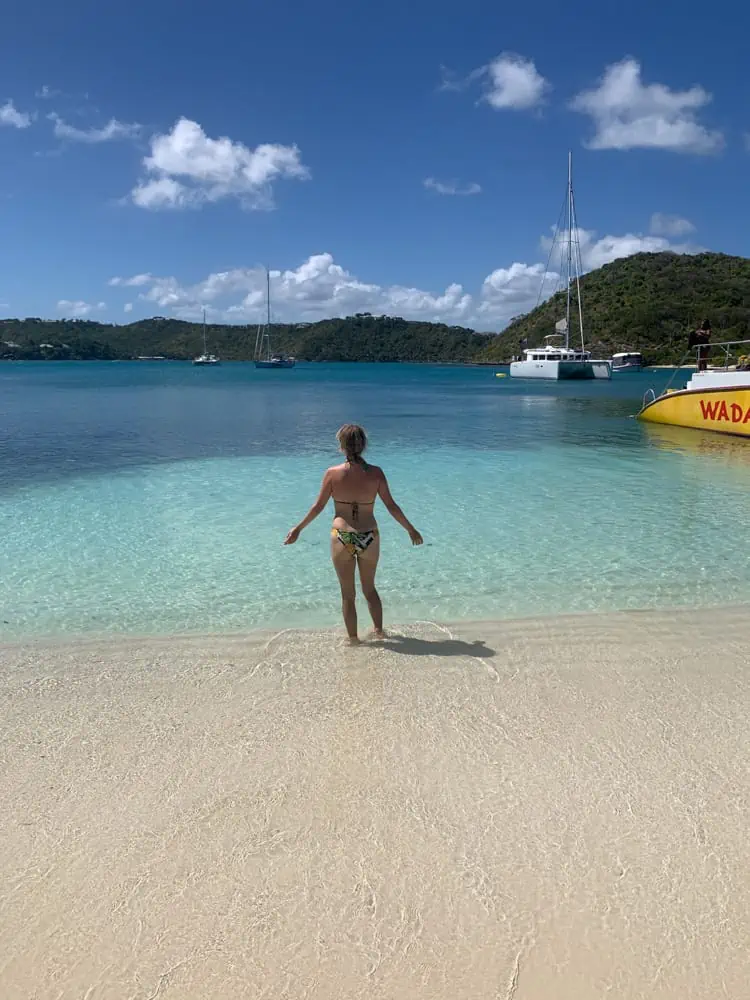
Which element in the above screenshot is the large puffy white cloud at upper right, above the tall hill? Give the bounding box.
[570,59,724,154]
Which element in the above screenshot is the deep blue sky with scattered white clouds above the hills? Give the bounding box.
[0,0,750,330]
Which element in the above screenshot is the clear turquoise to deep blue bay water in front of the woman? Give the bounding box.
[0,363,750,637]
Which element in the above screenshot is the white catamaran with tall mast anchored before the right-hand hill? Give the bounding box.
[510,153,612,379]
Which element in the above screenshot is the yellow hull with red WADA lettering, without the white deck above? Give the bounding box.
[638,386,750,438]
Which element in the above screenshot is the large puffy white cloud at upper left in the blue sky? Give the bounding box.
[131,118,310,209]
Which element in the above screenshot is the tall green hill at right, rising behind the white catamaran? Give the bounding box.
[482,253,750,364]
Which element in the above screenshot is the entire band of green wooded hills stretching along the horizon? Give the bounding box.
[0,253,750,364]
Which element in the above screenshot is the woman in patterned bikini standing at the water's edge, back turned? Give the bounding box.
[284,424,423,645]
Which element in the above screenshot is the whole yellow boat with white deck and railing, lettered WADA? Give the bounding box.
[638,340,750,437]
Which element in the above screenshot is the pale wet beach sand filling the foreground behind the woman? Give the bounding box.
[0,608,750,1000]
